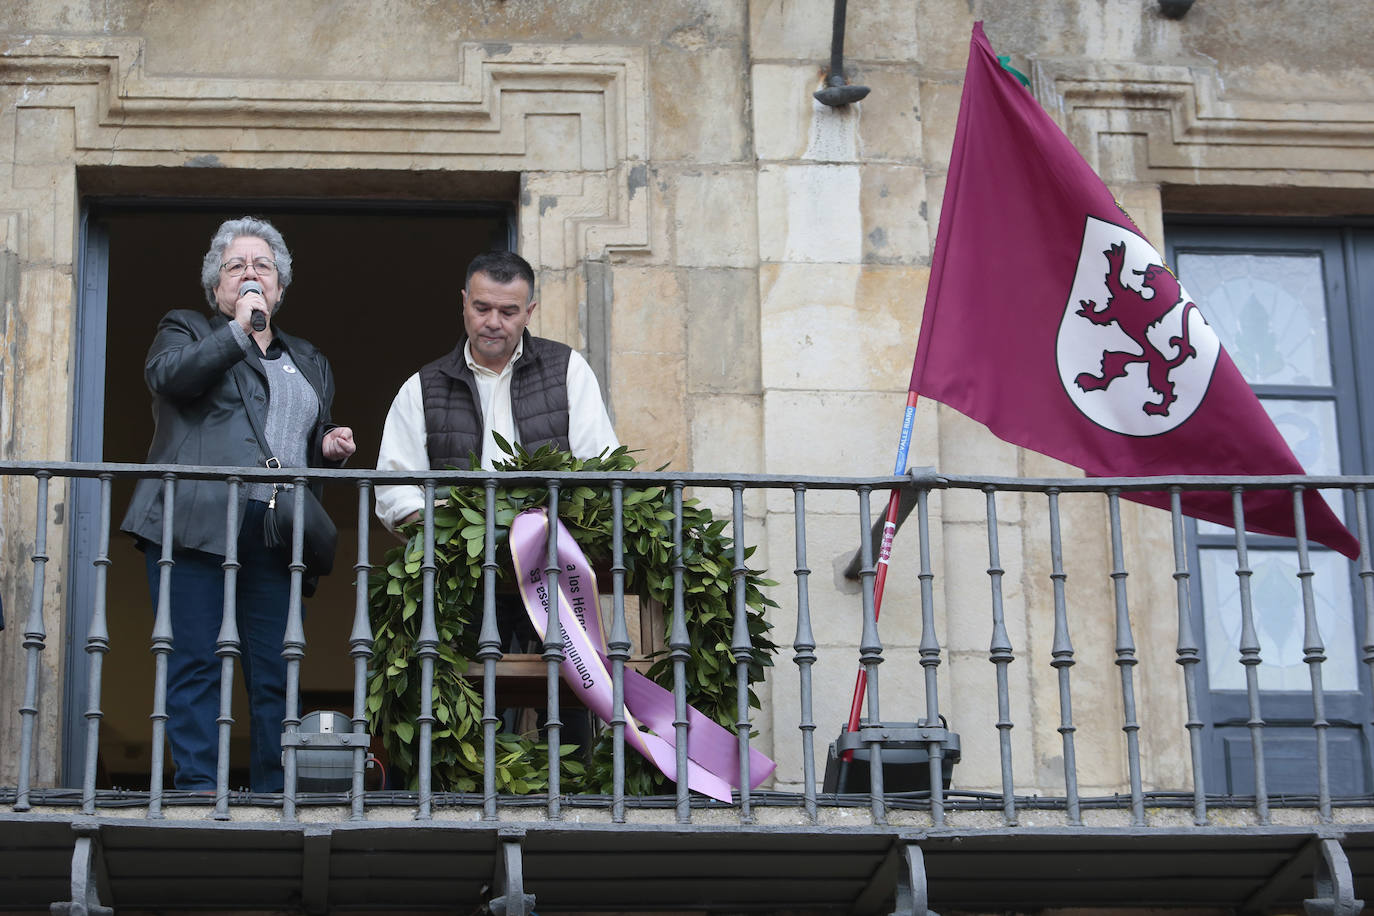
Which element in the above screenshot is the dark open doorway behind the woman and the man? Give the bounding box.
[63,197,514,788]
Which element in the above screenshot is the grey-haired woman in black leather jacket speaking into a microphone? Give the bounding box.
[121,217,354,792]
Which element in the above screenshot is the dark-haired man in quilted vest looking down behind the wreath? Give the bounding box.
[376,251,620,531]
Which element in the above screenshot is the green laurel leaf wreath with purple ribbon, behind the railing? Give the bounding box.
[367,441,776,795]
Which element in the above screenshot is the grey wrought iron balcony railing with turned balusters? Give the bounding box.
[0,461,1374,824]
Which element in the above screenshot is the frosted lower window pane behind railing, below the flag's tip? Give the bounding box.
[1198,548,1359,694]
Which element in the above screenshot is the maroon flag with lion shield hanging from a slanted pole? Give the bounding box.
[911,23,1359,559]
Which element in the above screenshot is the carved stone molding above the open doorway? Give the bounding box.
[0,36,650,269]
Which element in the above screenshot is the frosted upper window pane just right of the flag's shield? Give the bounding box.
[1178,251,1331,386]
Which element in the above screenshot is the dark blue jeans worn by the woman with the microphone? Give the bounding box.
[144,500,291,792]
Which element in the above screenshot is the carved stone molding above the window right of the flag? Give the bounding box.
[1032,60,1374,188]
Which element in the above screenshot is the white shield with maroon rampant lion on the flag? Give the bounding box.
[1055,217,1221,437]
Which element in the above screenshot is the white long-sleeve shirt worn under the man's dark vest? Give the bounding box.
[376,342,620,530]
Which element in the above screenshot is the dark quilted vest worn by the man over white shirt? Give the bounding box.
[420,331,573,470]
